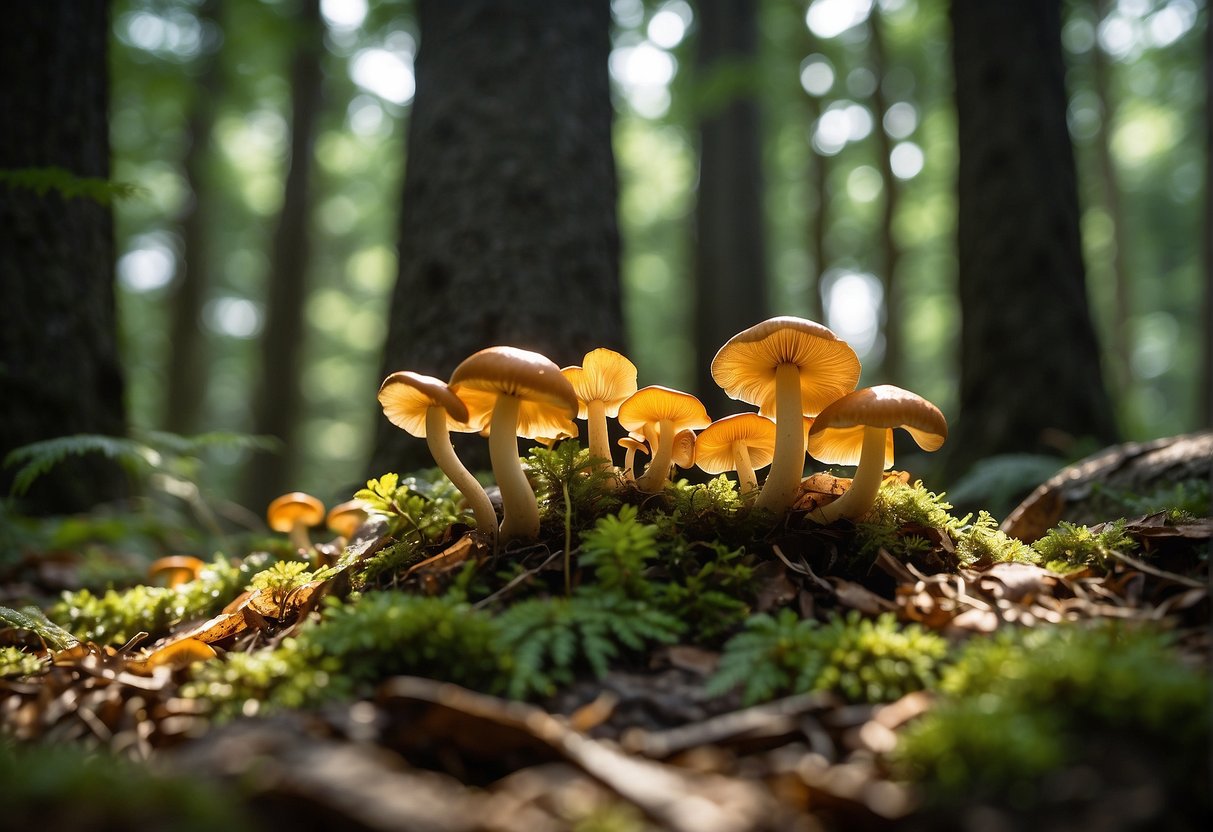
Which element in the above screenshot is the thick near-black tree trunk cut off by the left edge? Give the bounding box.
[0,0,126,512]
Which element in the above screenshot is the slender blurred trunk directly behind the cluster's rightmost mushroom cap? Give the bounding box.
[867,6,905,383]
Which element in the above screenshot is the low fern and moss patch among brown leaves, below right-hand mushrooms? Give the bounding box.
[707,609,947,705]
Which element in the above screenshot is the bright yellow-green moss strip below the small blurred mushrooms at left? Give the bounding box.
[49,553,269,644]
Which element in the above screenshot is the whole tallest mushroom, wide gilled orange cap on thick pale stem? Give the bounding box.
[712,317,860,514]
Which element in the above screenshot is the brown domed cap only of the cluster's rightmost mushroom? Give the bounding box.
[808,384,947,468]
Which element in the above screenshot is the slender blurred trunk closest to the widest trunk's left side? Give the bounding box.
[245,0,324,509]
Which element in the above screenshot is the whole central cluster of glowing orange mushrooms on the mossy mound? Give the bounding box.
[378,317,947,542]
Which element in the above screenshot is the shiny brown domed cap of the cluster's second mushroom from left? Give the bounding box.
[450,347,577,426]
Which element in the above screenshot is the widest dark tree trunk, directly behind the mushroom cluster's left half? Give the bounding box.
[370,0,622,474]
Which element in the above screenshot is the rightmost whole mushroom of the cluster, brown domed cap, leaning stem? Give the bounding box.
[809,384,947,523]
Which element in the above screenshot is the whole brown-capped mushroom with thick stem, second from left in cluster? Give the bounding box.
[450,347,577,540]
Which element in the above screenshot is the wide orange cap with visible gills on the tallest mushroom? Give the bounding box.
[712,315,860,416]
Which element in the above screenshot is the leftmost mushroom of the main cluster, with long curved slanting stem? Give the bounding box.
[378,370,497,540]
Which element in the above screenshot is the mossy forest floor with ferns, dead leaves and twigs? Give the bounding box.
[0,439,1213,832]
